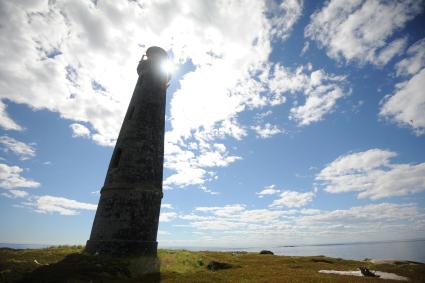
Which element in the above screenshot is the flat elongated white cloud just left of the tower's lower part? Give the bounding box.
[30,195,97,215]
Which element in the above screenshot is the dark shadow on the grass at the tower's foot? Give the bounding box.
[17,253,160,283]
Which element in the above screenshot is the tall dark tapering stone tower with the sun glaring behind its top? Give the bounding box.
[86,47,170,256]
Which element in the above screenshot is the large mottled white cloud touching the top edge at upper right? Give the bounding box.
[305,0,423,65]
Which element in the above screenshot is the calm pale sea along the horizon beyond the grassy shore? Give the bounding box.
[0,242,425,263]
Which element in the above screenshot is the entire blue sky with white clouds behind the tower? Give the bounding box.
[0,0,425,247]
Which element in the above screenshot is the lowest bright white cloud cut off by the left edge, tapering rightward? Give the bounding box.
[0,164,40,189]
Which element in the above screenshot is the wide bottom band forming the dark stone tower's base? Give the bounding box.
[85,240,158,257]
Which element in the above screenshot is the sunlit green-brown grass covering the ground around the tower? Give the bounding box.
[0,246,425,283]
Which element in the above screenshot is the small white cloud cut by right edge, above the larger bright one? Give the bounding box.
[396,38,425,76]
